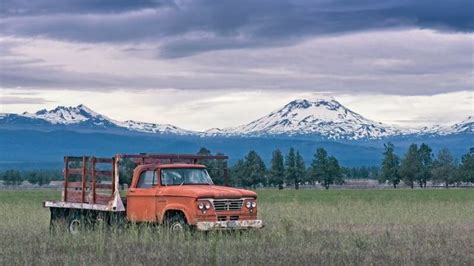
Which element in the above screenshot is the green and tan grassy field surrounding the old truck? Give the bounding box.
[0,189,474,265]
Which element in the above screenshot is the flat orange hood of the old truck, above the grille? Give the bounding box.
[159,185,257,199]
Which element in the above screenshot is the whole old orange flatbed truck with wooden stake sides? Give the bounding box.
[44,154,263,233]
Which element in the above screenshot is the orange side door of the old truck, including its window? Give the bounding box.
[127,169,159,222]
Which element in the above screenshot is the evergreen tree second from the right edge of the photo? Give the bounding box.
[431,148,456,188]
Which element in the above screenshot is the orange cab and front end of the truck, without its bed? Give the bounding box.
[126,164,262,231]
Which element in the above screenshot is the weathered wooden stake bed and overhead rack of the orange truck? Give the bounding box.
[44,153,228,212]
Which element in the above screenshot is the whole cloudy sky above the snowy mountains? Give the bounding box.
[0,0,474,130]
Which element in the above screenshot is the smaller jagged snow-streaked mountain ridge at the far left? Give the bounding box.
[0,104,194,135]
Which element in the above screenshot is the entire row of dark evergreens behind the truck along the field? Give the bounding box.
[0,142,474,189]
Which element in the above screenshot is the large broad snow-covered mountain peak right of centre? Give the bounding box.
[206,99,404,140]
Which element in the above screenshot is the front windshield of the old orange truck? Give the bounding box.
[161,168,214,186]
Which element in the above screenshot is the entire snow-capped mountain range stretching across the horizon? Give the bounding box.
[0,99,474,140]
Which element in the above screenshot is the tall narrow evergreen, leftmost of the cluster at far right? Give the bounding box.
[379,142,400,188]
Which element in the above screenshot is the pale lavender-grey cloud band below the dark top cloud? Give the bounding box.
[0,30,473,95]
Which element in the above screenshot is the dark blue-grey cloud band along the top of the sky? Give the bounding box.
[0,0,474,58]
